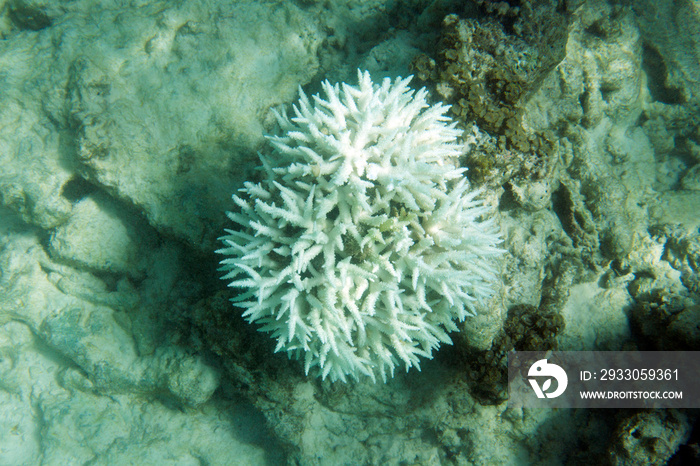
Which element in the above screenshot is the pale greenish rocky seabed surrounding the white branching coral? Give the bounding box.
[0,0,700,465]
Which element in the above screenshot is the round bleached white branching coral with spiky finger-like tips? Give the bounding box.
[217,72,502,381]
